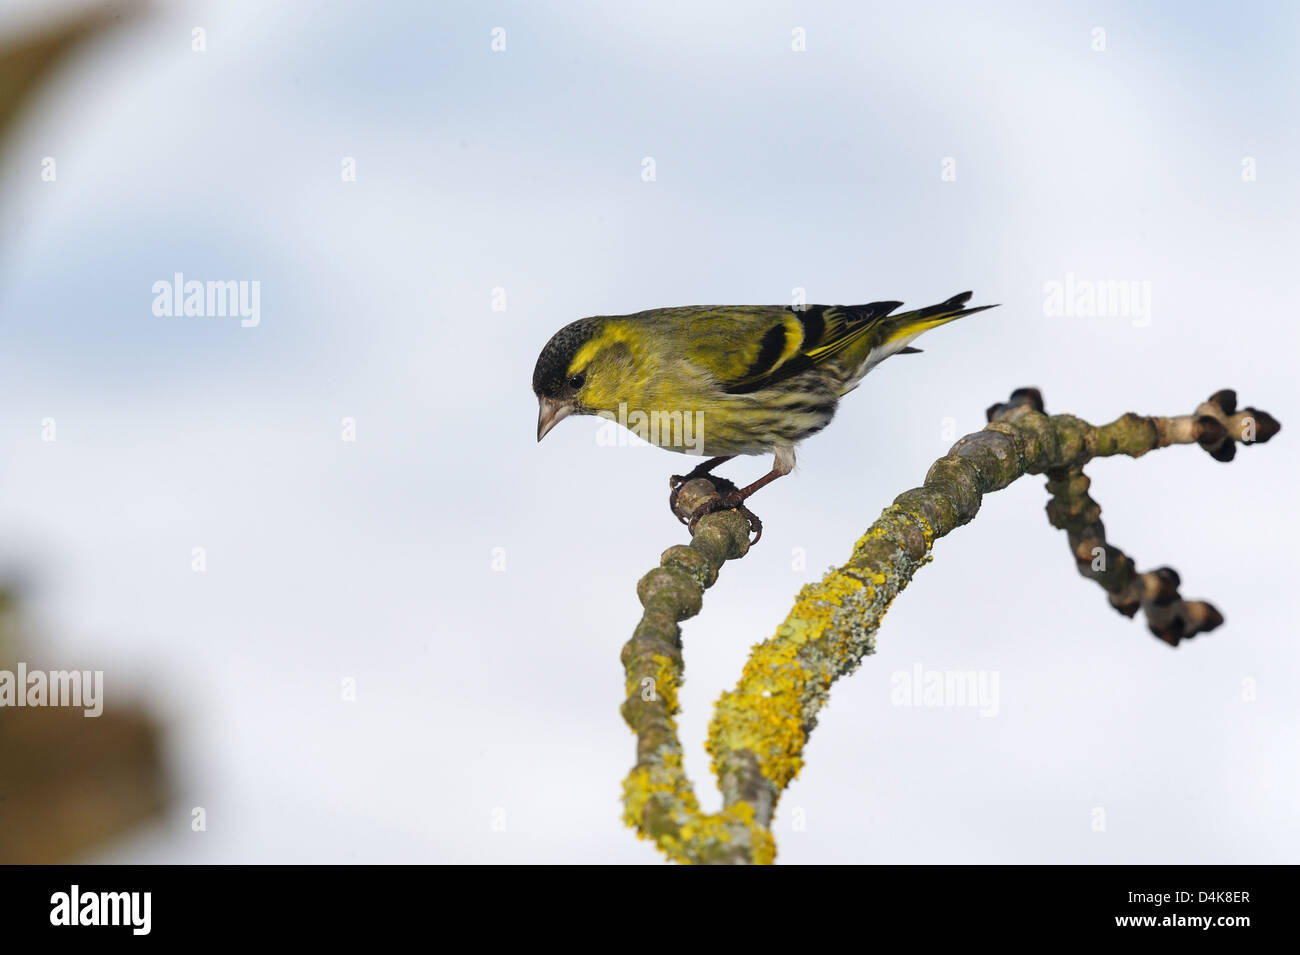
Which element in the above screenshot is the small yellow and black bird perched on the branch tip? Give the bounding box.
[533,291,996,543]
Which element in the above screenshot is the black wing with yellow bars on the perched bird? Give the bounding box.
[711,301,902,395]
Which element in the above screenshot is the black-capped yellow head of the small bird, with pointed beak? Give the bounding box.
[533,317,633,440]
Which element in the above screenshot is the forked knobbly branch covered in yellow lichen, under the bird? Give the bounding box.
[623,388,1279,864]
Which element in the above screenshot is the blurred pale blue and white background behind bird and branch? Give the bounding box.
[0,0,1300,863]
